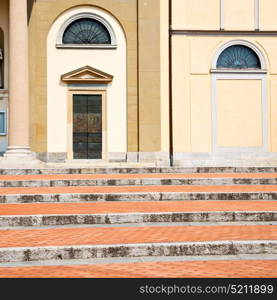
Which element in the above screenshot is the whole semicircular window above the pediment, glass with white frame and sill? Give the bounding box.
[56,13,116,48]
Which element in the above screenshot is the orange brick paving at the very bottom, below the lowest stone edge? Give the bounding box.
[0,260,277,278]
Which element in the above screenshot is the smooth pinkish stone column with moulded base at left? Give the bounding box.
[5,0,34,163]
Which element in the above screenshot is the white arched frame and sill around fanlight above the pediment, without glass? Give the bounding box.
[56,13,117,49]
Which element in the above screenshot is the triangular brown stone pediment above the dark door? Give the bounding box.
[61,66,113,84]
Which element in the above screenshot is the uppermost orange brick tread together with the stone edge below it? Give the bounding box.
[0,173,277,187]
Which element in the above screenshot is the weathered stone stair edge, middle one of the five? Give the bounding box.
[0,192,277,203]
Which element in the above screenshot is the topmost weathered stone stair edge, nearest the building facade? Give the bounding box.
[0,167,277,175]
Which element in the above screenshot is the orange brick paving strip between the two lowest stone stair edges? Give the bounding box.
[0,225,277,248]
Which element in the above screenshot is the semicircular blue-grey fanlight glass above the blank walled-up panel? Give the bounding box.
[216,45,261,69]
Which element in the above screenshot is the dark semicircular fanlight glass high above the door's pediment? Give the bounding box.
[63,18,111,45]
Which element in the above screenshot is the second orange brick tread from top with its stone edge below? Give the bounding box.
[0,185,277,203]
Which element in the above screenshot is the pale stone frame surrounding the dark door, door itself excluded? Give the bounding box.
[67,89,107,161]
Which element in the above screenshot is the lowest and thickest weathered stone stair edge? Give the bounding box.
[0,240,277,263]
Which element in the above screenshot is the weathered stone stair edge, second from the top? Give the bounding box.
[0,178,277,188]
